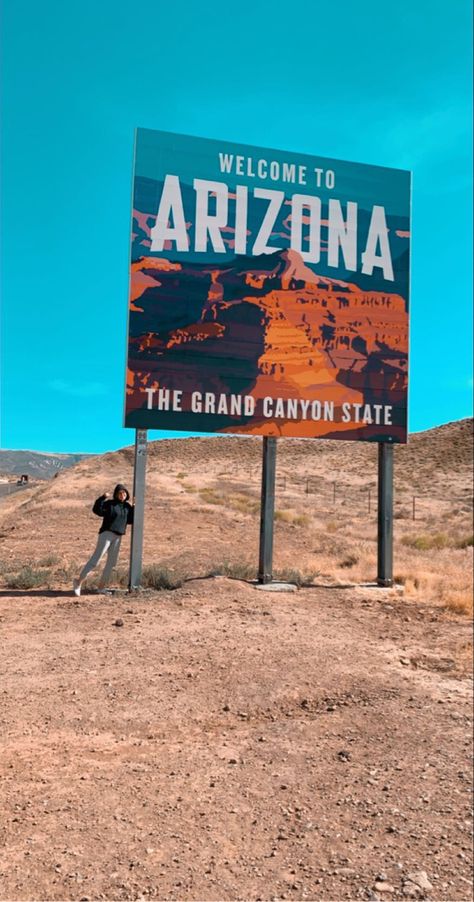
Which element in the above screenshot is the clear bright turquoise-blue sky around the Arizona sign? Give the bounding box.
[0,0,472,452]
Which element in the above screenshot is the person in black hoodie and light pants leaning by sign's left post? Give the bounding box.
[73,483,133,595]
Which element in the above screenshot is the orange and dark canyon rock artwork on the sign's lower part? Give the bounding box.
[126,250,408,441]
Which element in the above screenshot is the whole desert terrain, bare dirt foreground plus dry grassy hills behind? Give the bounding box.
[0,420,472,902]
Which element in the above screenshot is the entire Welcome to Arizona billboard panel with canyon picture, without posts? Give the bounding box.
[125,129,410,442]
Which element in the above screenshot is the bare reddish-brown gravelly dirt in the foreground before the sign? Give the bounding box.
[0,578,472,900]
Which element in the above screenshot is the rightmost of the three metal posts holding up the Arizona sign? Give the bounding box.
[377,442,393,588]
